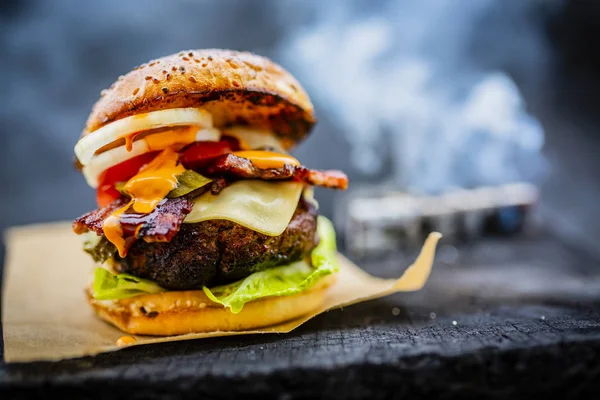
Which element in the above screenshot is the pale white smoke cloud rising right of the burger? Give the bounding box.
[279,0,547,193]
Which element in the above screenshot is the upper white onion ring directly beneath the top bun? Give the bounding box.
[75,108,213,165]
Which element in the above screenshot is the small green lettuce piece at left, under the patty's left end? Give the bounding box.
[93,268,165,300]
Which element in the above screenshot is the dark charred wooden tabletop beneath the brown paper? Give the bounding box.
[0,235,600,398]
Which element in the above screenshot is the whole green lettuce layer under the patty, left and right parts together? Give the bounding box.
[93,216,339,314]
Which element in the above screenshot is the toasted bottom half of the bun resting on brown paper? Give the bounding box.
[87,275,335,336]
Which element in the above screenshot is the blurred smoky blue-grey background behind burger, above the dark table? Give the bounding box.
[0,0,600,256]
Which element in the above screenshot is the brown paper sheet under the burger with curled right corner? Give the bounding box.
[2,223,441,362]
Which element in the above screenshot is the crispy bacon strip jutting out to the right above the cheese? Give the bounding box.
[201,154,348,190]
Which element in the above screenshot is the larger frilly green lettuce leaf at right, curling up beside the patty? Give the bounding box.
[203,216,339,314]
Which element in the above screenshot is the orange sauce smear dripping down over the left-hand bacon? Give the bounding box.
[102,148,185,257]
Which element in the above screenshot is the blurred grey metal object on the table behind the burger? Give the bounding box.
[336,182,539,256]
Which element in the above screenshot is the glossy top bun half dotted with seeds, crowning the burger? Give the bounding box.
[82,49,316,149]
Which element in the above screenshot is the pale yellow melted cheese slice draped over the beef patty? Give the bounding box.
[183,180,304,236]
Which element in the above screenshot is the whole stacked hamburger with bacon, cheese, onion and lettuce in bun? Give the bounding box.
[73,49,348,335]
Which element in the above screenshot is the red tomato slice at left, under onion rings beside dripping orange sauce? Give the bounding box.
[96,151,157,207]
